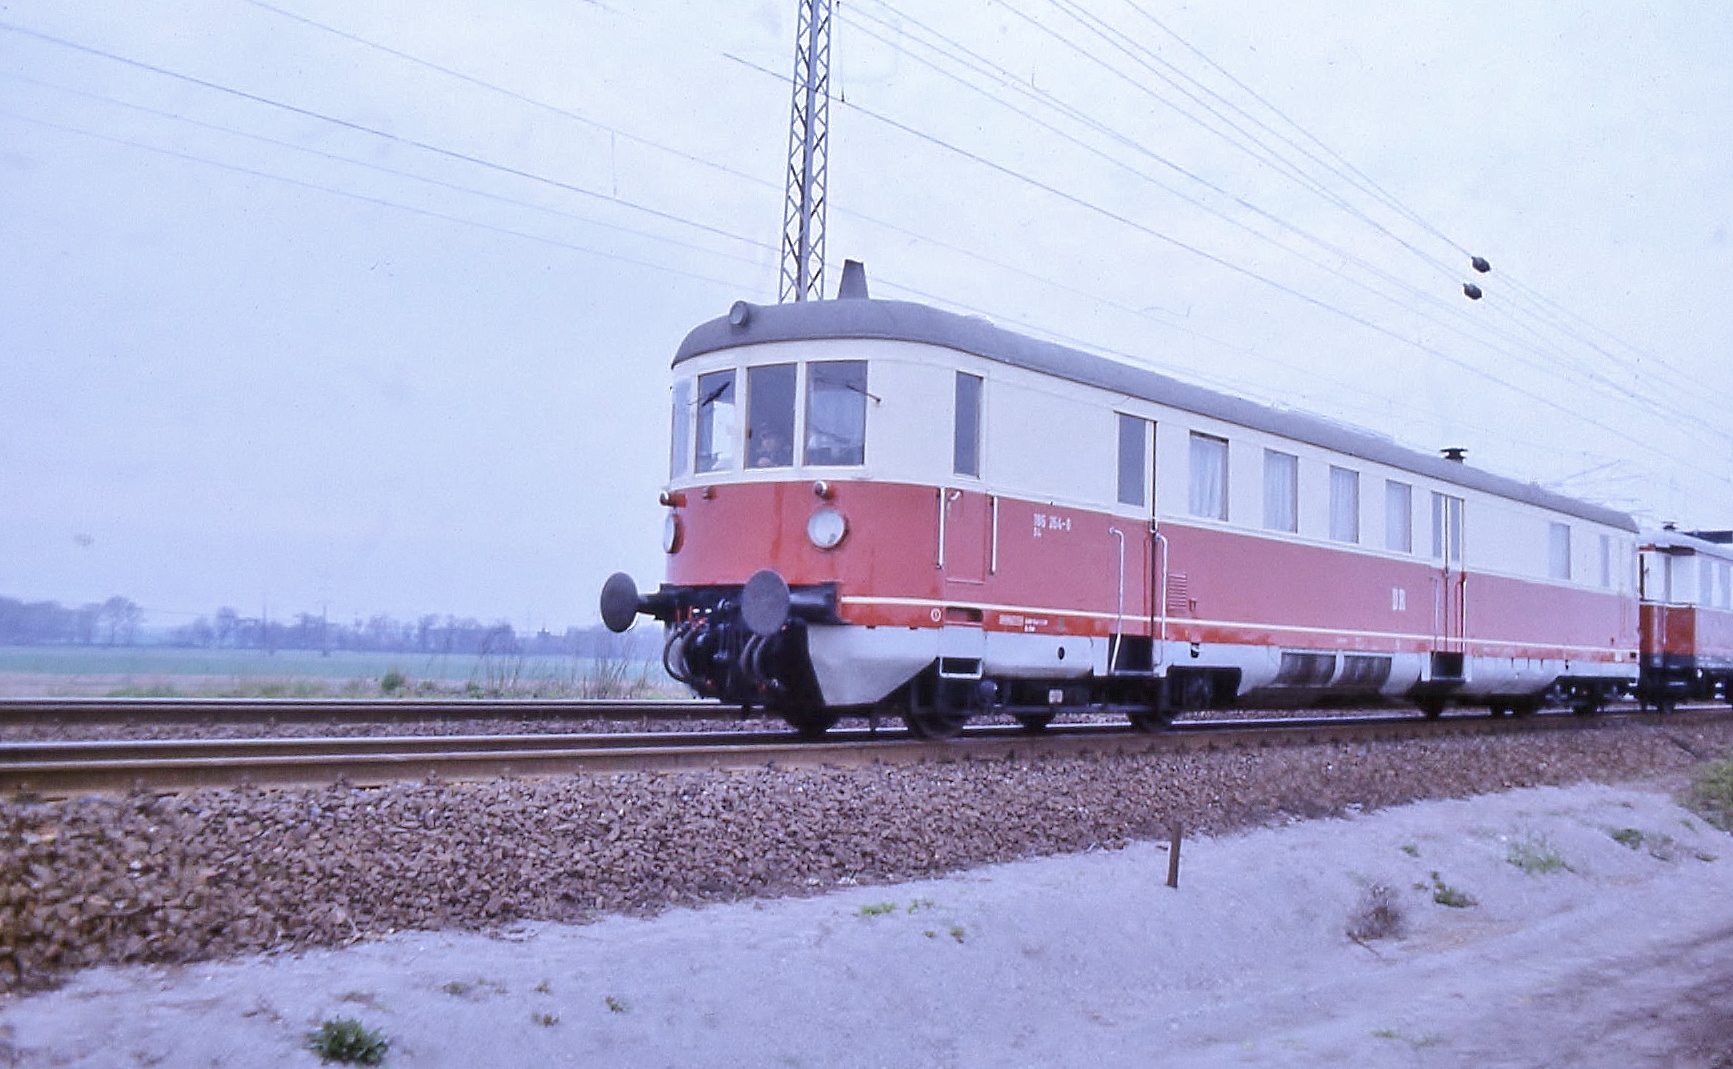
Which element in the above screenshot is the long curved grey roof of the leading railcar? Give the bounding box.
[674,300,1638,532]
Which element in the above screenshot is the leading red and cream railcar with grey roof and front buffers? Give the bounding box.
[603,275,1638,735]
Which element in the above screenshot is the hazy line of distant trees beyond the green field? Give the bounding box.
[0,596,657,657]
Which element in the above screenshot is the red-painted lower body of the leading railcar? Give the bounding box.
[667,482,1635,662]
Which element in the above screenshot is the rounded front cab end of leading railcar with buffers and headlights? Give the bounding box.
[601,301,877,735]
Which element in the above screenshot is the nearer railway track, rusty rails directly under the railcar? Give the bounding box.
[0,707,1728,799]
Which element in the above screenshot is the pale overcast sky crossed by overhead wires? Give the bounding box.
[0,0,1733,627]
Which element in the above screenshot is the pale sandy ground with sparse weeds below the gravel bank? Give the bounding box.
[0,783,1733,1069]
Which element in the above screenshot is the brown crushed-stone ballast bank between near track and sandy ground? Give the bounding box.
[13,713,1733,991]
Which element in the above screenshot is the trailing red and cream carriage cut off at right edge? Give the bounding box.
[1639,530,1733,707]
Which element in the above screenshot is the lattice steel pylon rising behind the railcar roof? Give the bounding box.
[778,0,830,301]
